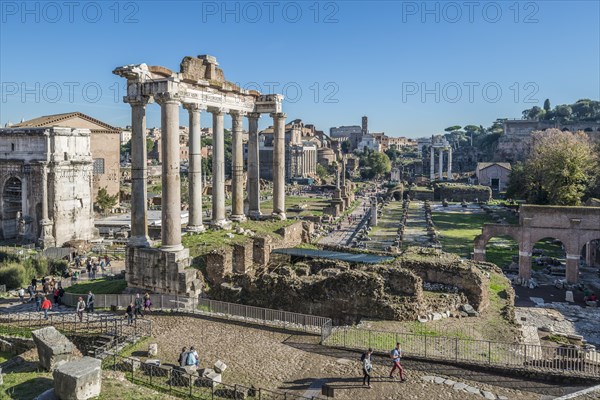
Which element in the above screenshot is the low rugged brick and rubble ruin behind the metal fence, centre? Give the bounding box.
[208,250,494,324]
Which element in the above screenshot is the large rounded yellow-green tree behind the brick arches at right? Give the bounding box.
[507,129,599,206]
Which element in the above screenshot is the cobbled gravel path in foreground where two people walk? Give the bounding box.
[140,315,584,400]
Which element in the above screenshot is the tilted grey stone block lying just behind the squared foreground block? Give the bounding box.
[31,326,75,371]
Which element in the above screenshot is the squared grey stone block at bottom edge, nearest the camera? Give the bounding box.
[52,357,102,400]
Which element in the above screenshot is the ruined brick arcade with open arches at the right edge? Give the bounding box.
[473,205,600,283]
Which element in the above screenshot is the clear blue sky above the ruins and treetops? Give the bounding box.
[0,1,600,137]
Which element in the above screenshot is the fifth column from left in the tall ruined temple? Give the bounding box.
[230,111,246,222]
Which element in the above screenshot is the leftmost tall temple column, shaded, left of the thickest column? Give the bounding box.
[128,97,150,247]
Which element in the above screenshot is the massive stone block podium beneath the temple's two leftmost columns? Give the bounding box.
[125,247,203,297]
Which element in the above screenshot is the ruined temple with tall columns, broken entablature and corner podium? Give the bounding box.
[113,55,286,295]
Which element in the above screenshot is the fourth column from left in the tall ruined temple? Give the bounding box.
[209,108,229,229]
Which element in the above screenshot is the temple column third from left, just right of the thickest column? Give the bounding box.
[183,104,205,232]
